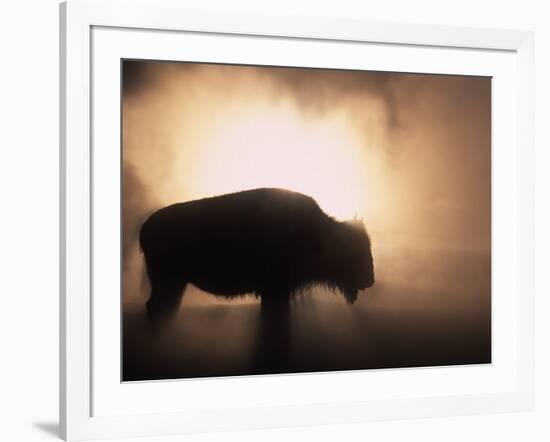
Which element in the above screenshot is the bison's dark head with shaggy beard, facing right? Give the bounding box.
[330,219,374,304]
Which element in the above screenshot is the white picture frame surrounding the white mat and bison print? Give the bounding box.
[60,0,534,440]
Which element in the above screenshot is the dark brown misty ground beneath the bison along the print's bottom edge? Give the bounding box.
[123,250,491,381]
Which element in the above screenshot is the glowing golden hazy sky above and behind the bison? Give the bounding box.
[123,61,491,304]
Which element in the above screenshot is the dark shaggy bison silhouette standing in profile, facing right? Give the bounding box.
[139,188,374,319]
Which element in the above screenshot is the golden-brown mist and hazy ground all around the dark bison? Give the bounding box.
[122,61,491,380]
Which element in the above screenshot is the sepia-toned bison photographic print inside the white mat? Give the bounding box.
[121,60,491,381]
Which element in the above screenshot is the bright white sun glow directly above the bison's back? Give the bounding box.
[187,106,367,219]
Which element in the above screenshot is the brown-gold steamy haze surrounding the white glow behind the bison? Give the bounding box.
[123,61,491,300]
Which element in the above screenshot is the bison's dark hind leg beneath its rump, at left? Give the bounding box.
[146,278,186,322]
